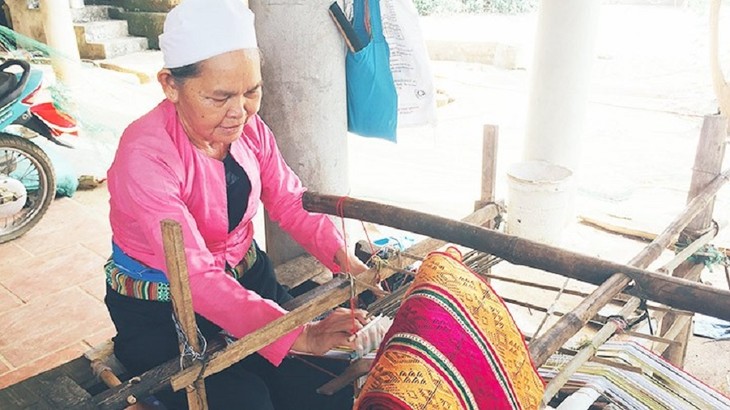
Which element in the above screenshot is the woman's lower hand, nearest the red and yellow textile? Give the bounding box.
[291,308,368,355]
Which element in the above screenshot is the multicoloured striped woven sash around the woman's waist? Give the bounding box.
[104,242,257,302]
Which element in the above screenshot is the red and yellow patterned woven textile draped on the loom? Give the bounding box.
[355,248,545,410]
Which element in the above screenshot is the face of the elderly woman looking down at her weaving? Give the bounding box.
[163,49,261,144]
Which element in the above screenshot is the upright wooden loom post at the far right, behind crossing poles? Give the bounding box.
[661,115,727,368]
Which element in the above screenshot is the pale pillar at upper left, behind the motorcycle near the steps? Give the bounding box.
[40,0,81,85]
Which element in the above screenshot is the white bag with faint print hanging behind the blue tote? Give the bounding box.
[380,0,436,127]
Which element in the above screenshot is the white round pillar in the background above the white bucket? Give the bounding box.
[523,0,601,171]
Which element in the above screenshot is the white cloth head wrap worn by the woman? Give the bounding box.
[160,0,258,68]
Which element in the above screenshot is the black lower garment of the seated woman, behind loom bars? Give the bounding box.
[105,247,353,410]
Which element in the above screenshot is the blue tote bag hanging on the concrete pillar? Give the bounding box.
[345,0,398,142]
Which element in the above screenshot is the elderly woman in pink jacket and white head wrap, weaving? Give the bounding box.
[105,0,366,409]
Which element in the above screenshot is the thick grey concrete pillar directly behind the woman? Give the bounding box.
[249,0,349,264]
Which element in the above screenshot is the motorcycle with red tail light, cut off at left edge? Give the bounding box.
[0,59,77,243]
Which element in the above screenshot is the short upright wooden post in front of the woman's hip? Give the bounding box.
[160,219,208,410]
